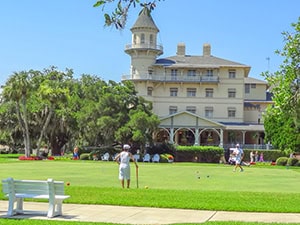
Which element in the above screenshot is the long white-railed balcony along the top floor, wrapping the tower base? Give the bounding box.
[122,74,219,83]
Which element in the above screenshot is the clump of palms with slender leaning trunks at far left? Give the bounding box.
[1,67,72,157]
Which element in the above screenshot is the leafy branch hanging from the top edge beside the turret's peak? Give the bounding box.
[94,0,160,30]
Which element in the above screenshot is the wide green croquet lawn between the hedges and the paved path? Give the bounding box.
[0,157,300,225]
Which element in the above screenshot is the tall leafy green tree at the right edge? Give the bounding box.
[263,17,300,151]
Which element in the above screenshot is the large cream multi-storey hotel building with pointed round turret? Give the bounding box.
[122,8,272,148]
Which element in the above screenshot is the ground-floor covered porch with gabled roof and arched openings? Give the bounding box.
[154,111,266,149]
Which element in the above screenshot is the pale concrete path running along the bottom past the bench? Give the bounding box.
[0,201,300,224]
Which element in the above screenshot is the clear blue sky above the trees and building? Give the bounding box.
[0,0,300,84]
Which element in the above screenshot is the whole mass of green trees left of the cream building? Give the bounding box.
[0,67,159,156]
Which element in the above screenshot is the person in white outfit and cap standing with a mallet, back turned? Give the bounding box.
[115,144,138,188]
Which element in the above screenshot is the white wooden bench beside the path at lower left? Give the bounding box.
[2,178,70,218]
